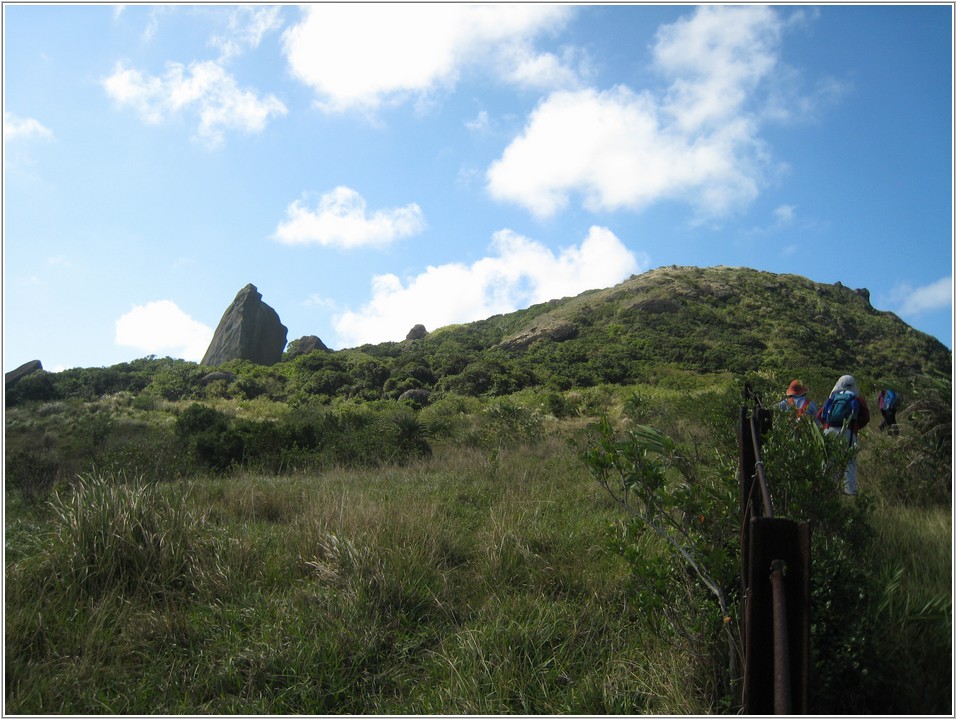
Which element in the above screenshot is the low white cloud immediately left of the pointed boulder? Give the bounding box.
[115,300,213,362]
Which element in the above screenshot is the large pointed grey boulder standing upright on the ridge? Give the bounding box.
[200,284,288,366]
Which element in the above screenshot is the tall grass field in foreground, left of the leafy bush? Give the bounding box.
[6,440,672,714]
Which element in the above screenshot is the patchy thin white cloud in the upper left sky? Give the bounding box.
[103,61,286,146]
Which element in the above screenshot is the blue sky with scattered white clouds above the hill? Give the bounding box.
[3,4,954,371]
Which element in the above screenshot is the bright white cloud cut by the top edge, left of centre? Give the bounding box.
[283,3,582,111]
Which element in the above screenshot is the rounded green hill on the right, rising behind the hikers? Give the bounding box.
[390,267,951,386]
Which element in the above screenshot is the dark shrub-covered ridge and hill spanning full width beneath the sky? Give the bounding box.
[7,267,951,407]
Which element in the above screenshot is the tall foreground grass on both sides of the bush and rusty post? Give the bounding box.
[5,394,952,715]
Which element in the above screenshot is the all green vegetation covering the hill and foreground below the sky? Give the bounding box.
[5,269,952,714]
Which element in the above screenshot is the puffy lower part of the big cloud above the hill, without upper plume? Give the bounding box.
[486,86,758,217]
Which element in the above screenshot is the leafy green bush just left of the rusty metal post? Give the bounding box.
[580,418,741,703]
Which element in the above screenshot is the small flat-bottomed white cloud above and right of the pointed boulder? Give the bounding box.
[273,186,425,248]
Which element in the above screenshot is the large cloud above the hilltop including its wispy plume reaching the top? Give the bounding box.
[486,6,782,217]
